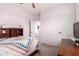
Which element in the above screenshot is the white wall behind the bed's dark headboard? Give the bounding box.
[0,4,34,36]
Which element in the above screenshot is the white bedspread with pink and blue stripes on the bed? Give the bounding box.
[0,38,37,56]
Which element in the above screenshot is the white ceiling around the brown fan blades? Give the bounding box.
[15,3,60,14]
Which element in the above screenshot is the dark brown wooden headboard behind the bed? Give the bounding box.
[0,28,23,38]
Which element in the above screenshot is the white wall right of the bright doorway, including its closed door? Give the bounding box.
[40,4,75,46]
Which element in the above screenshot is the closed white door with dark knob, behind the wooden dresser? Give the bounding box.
[58,13,75,44]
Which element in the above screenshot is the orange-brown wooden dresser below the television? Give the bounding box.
[58,39,79,56]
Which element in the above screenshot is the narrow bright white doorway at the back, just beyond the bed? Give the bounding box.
[31,21,40,41]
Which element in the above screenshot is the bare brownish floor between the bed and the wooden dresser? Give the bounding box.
[32,44,58,56]
